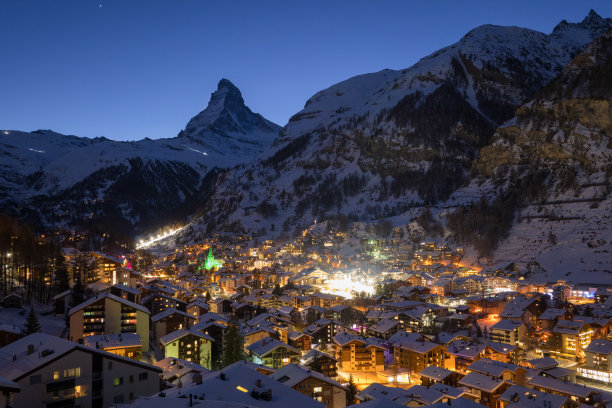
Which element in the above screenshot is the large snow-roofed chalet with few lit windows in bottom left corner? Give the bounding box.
[0,333,162,408]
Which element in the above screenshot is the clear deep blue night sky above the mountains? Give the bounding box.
[0,0,612,140]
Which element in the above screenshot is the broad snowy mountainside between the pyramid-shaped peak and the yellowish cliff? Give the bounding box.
[185,12,612,240]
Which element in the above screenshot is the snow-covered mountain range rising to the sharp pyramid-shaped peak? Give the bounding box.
[0,79,280,236]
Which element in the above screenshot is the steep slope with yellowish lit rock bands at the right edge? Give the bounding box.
[450,31,612,283]
